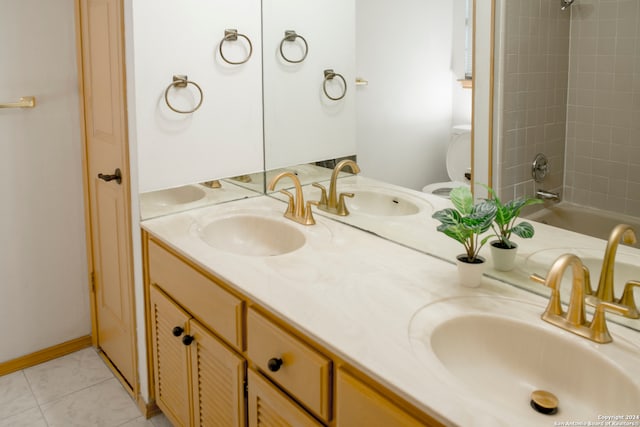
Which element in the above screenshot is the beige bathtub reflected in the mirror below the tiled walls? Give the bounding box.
[526,202,640,240]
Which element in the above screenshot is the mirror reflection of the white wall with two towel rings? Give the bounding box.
[262,0,356,170]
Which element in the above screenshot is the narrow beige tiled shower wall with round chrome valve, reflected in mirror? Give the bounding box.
[497,0,568,199]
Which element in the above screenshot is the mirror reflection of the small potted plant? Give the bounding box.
[485,187,542,271]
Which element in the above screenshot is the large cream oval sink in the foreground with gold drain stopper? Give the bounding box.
[410,297,640,425]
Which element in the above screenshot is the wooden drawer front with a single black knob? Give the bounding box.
[247,309,331,421]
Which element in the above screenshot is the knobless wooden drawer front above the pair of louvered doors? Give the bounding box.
[149,240,244,349]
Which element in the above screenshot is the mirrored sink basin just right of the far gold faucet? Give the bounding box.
[346,189,420,216]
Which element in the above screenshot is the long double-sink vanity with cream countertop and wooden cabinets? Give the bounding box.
[142,196,640,426]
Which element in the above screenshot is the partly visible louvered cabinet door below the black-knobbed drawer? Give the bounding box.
[247,369,322,427]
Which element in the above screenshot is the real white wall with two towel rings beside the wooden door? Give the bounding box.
[127,0,264,192]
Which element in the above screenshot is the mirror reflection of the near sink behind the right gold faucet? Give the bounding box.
[523,248,640,306]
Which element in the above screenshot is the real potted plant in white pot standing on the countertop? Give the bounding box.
[433,187,497,287]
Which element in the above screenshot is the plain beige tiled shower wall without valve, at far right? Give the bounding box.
[565,0,640,216]
